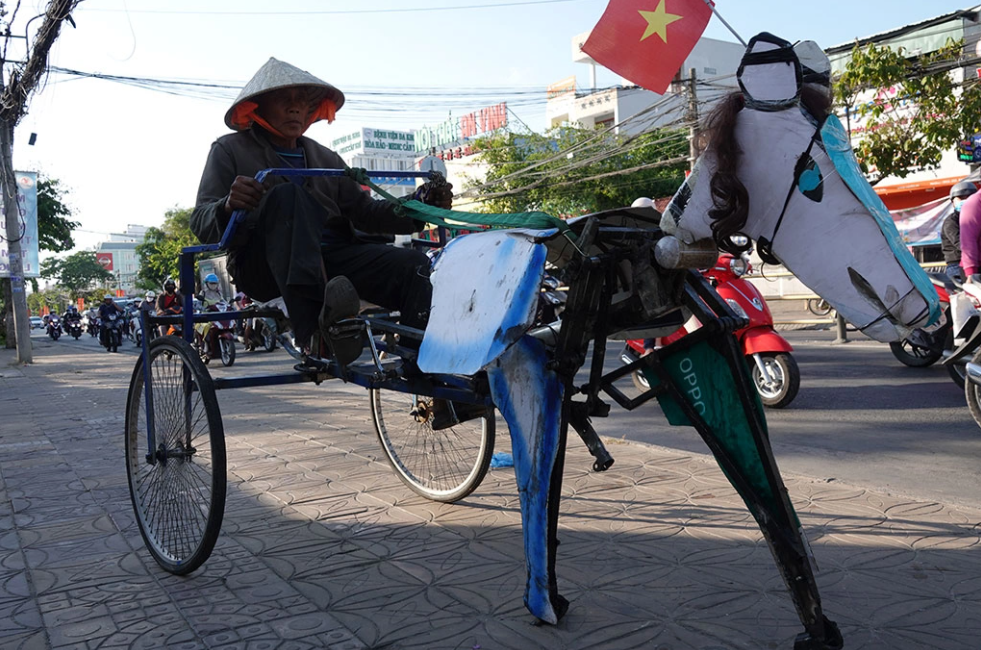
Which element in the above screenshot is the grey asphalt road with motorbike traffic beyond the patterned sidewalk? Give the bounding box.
[32,322,981,507]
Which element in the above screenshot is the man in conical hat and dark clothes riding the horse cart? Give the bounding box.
[191,58,482,428]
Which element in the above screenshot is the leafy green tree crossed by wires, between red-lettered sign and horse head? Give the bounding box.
[475,127,688,217]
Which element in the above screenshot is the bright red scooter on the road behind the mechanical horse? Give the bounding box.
[623,253,800,408]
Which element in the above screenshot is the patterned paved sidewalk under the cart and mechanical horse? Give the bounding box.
[0,340,981,650]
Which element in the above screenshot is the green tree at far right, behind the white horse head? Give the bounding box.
[833,40,981,184]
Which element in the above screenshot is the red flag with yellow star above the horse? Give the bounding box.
[582,0,712,94]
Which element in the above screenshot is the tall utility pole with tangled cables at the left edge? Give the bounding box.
[0,0,81,363]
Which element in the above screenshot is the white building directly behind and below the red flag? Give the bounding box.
[545,32,745,135]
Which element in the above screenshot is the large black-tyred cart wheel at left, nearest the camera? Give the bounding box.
[125,336,227,575]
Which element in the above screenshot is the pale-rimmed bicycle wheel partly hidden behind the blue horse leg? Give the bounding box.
[370,388,494,503]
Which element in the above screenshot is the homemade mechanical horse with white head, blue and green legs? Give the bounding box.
[418,33,938,649]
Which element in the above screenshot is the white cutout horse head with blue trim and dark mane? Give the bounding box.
[661,32,940,341]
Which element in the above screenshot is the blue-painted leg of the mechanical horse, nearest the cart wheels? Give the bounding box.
[487,336,569,625]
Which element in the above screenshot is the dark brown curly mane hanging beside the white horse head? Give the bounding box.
[703,92,749,256]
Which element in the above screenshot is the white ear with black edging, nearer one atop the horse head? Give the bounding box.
[736,32,801,111]
